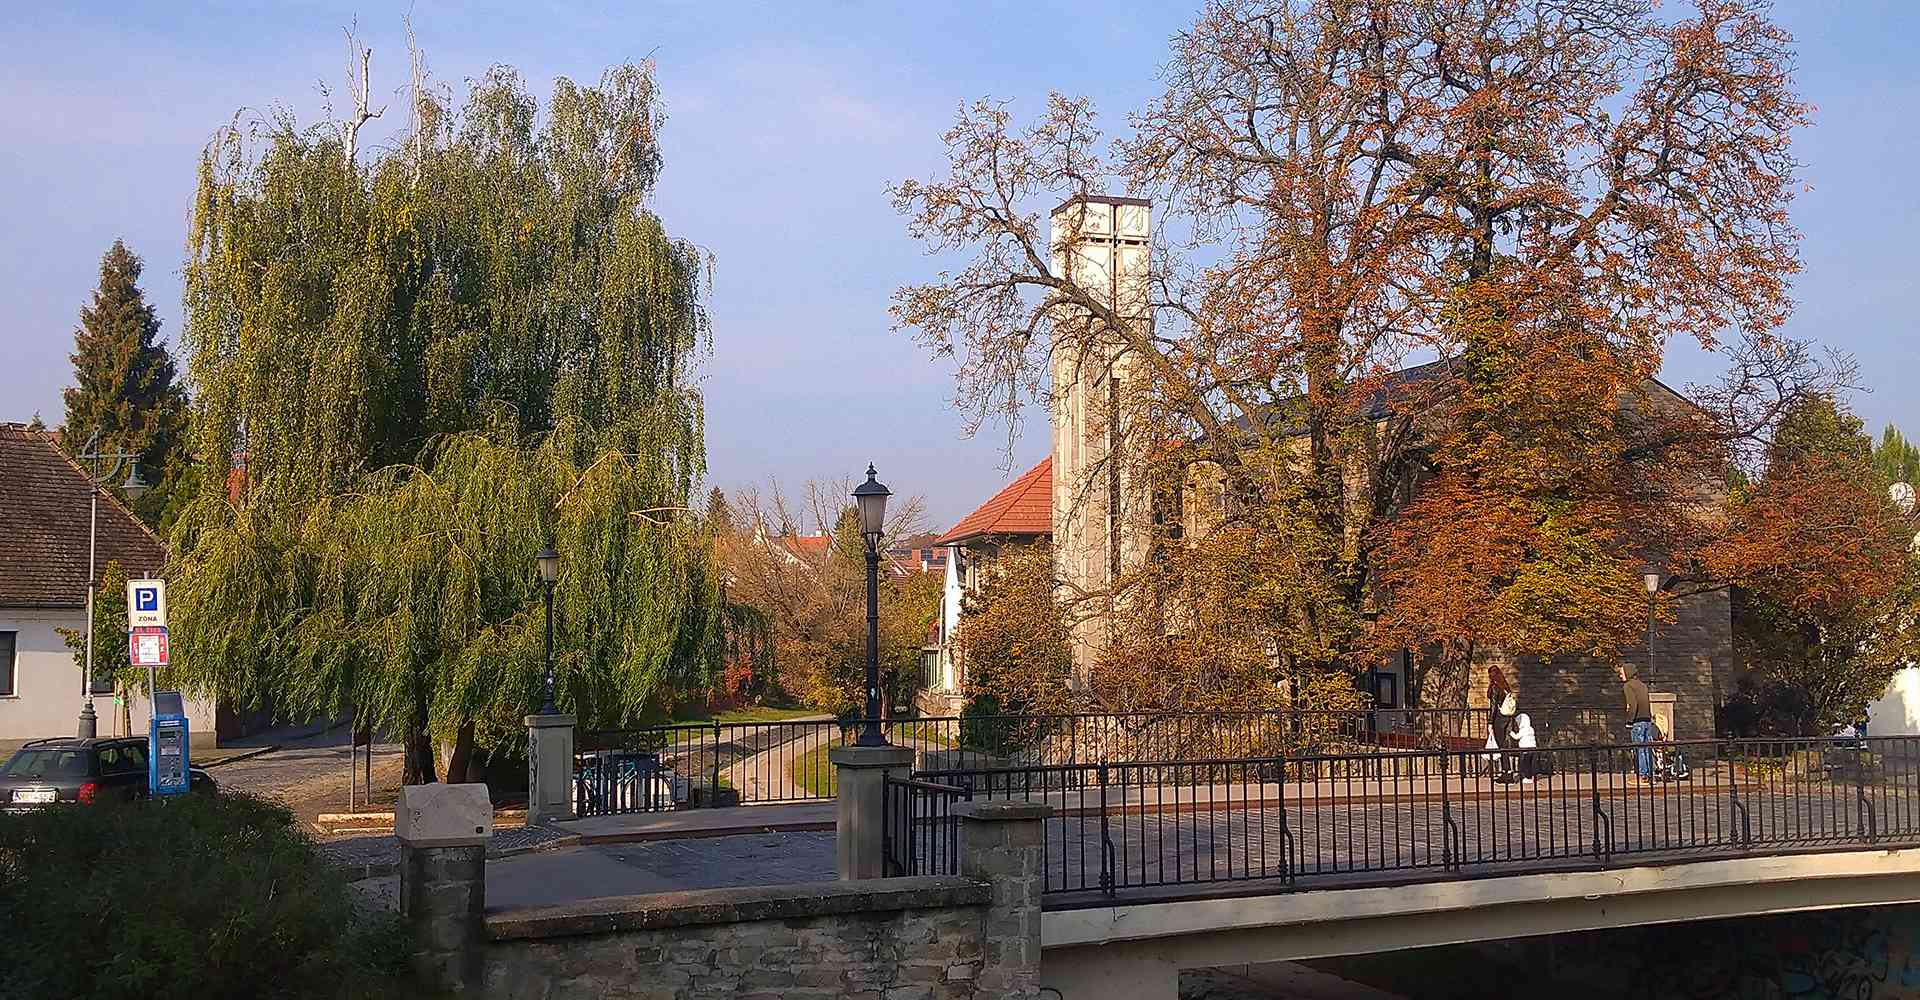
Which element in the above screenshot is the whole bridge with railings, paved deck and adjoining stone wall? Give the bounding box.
[428,720,1920,1000]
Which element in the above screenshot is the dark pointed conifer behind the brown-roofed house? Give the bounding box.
[60,240,190,524]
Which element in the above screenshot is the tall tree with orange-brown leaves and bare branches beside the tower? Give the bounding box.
[893,0,1889,710]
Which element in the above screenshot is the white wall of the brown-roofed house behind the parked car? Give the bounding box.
[0,608,213,745]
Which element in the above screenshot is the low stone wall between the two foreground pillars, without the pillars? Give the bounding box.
[482,877,998,1000]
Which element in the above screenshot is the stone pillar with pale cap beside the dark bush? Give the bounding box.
[394,785,493,992]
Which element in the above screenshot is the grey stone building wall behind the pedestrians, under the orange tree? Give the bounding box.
[1467,591,1736,745]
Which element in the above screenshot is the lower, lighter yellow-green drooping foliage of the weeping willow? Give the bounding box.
[175,424,722,747]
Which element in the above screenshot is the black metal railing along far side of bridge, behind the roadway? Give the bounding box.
[574,708,1549,816]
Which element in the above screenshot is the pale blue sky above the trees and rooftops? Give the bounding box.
[0,0,1920,526]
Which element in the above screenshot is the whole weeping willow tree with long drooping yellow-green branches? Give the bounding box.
[175,56,724,781]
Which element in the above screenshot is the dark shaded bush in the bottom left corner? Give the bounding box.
[0,795,419,1000]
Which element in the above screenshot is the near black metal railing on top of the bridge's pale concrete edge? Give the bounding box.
[916,737,1920,894]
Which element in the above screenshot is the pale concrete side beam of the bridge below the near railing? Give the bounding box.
[1041,848,1920,1000]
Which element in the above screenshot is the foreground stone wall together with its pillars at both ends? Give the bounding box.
[412,802,1050,1000]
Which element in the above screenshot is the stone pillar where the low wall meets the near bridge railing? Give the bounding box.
[954,800,1054,1000]
